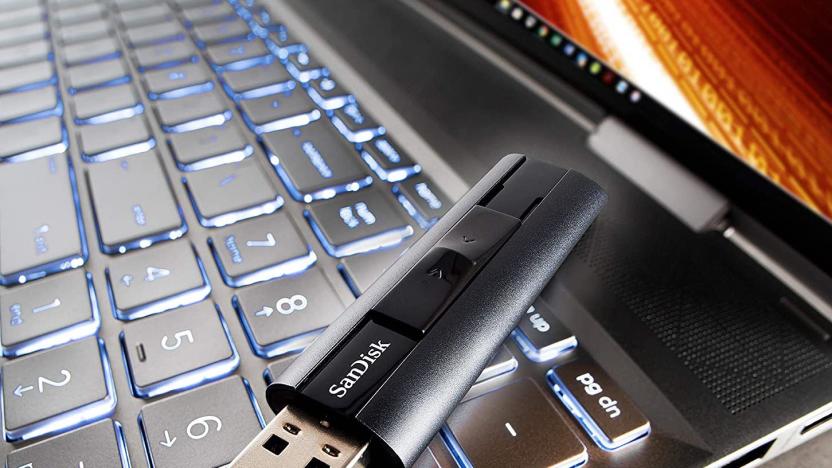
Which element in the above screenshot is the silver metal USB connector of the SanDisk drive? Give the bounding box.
[230,405,369,468]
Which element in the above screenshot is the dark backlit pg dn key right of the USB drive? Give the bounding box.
[548,357,650,450]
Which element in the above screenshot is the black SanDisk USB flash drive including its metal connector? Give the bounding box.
[232,155,606,467]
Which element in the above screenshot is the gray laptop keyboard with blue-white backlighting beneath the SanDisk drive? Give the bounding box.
[0,0,643,468]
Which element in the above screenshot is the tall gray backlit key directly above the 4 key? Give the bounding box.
[87,152,187,253]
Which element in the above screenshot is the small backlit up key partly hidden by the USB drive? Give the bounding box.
[511,301,578,362]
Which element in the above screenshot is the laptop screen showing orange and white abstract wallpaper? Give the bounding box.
[495,0,832,220]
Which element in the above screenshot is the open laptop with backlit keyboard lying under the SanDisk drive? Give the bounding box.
[0,0,832,468]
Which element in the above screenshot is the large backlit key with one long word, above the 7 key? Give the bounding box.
[263,119,372,202]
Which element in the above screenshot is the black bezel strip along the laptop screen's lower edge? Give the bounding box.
[446,0,832,274]
